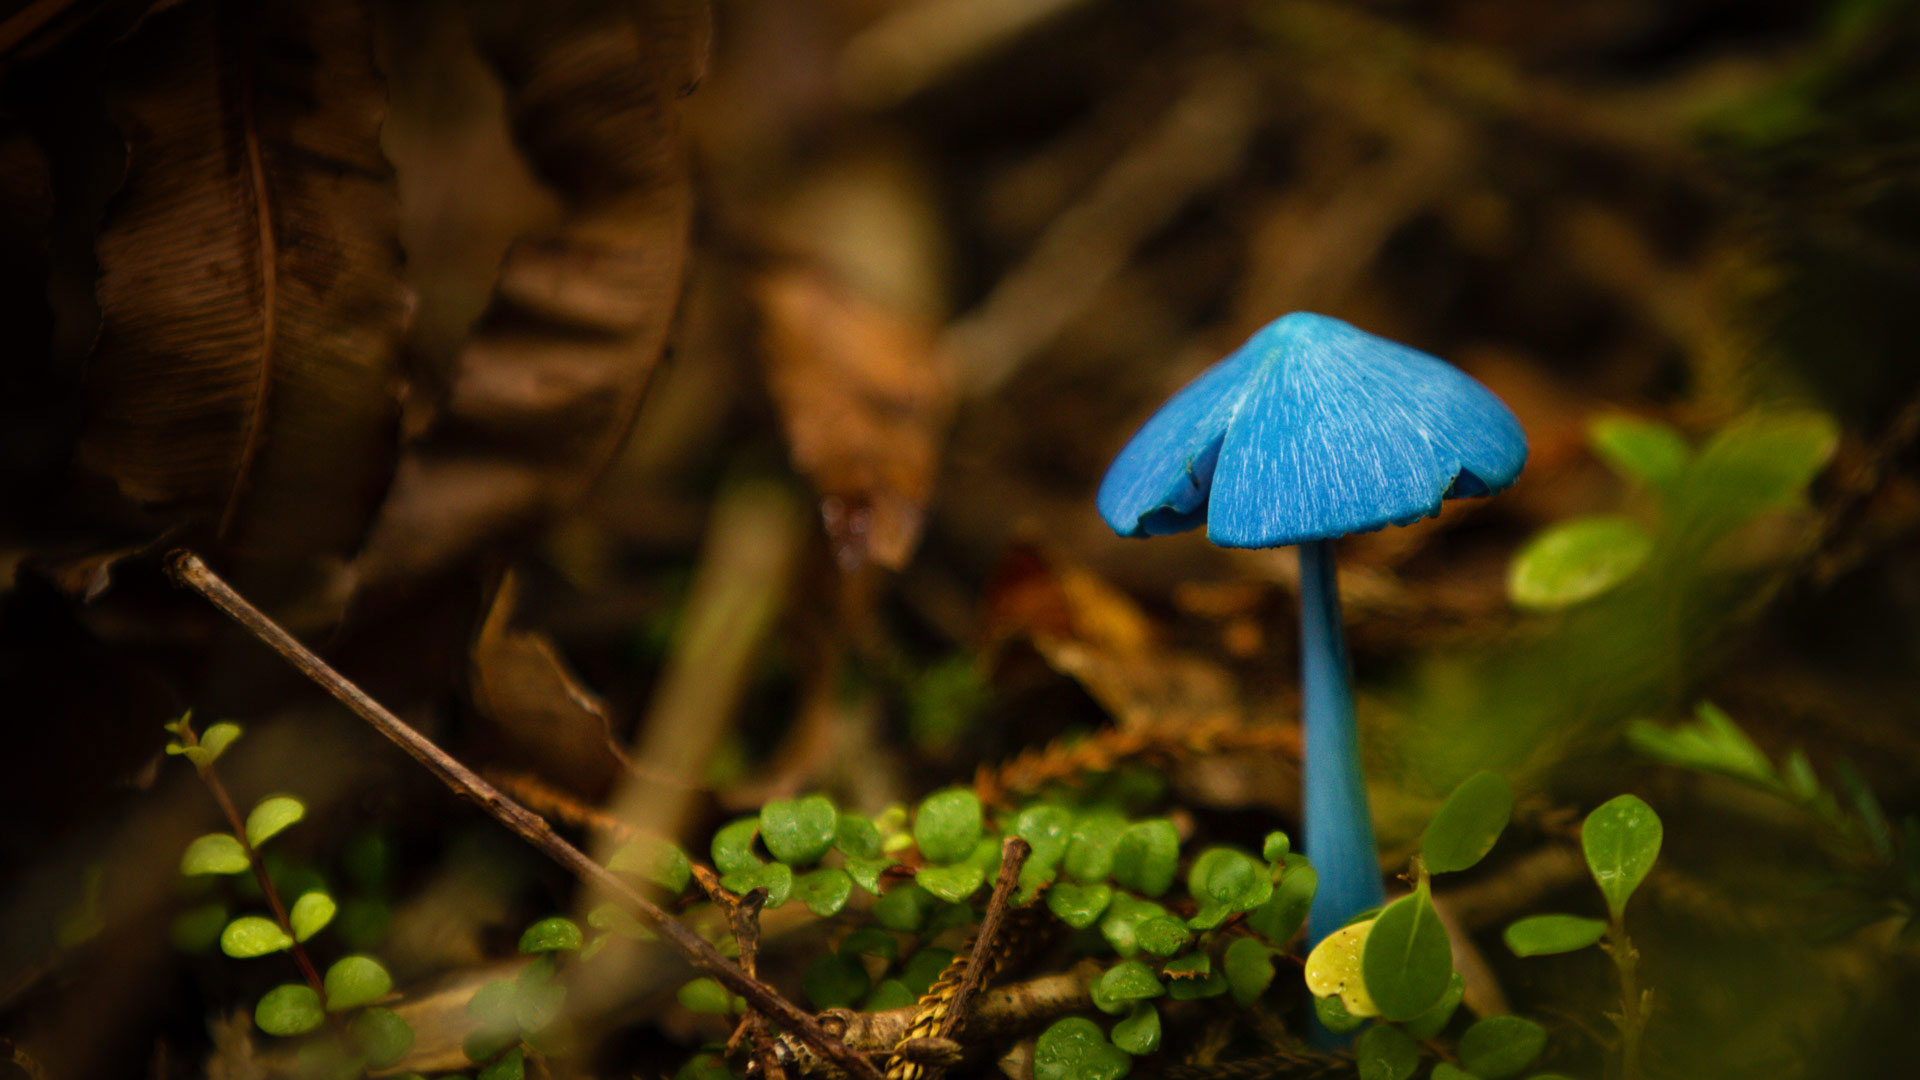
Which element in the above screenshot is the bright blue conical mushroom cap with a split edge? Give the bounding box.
[1098,311,1526,548]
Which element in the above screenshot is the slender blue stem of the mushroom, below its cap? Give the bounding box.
[1300,540,1384,945]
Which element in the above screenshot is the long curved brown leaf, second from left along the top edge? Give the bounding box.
[357,0,705,594]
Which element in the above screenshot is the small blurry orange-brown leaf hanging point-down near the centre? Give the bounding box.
[755,267,954,569]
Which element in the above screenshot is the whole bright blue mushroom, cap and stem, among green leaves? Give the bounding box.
[1098,311,1526,944]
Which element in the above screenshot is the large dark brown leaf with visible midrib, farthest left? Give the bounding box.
[81,0,411,561]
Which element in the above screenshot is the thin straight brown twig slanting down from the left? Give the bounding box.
[167,550,881,1080]
